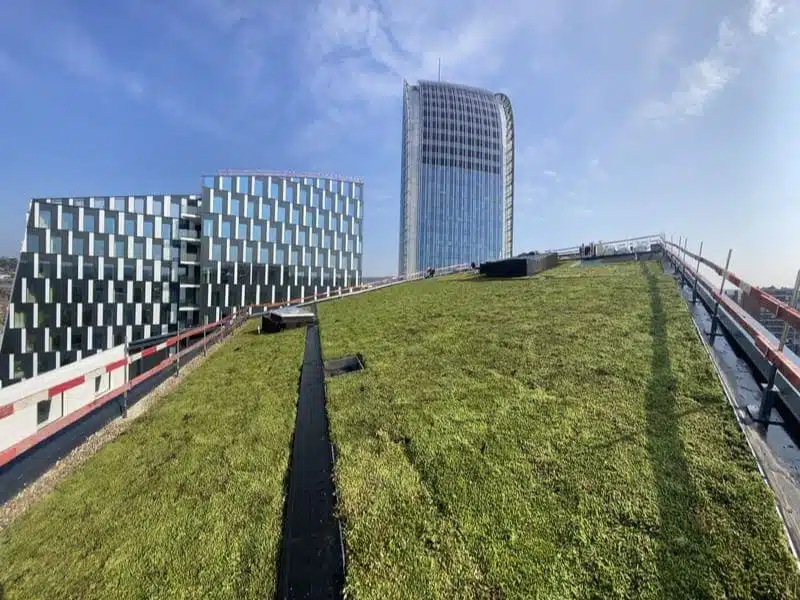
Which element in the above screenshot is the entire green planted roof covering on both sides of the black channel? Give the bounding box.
[0,262,800,599]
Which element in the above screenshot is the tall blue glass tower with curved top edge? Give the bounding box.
[398,81,514,275]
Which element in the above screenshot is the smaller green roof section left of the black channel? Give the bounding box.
[0,322,305,600]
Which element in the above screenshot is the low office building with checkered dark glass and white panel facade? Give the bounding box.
[0,172,363,386]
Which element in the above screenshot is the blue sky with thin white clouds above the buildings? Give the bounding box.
[0,0,800,285]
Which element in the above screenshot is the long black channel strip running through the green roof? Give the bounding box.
[277,324,344,600]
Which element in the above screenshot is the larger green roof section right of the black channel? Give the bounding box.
[319,263,798,600]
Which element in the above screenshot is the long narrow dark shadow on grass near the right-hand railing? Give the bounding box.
[641,262,711,598]
